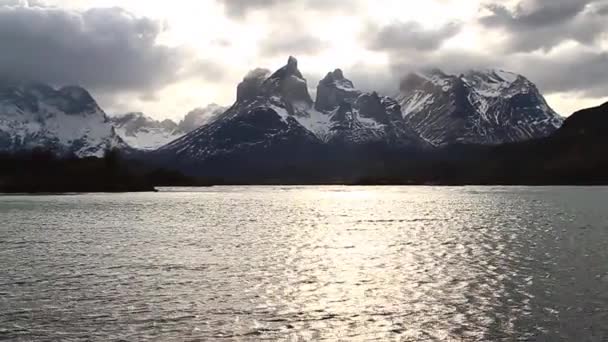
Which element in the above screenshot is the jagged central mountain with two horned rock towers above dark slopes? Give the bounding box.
[159,57,427,174]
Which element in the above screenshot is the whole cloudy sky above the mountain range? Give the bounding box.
[0,0,608,118]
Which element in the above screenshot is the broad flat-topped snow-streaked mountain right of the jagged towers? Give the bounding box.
[397,70,563,146]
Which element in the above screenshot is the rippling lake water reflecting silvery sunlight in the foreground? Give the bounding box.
[0,187,608,341]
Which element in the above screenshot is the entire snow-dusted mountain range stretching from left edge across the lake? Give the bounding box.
[0,57,600,180]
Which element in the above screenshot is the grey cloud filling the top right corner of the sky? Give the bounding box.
[480,0,608,52]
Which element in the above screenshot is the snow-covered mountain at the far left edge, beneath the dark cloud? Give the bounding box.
[0,84,128,157]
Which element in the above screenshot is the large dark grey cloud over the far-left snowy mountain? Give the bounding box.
[0,0,221,93]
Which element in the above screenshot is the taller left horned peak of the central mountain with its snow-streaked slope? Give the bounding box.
[159,58,318,162]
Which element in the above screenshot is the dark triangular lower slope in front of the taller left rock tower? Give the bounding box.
[155,98,319,181]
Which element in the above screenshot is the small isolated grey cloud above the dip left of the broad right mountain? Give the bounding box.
[363,22,462,52]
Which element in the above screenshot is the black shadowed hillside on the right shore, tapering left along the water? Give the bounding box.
[380,103,608,185]
